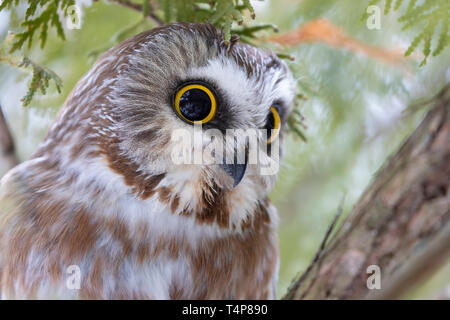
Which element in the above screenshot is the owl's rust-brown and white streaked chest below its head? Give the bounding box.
[0,166,278,299]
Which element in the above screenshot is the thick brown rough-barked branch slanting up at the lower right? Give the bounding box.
[284,86,450,299]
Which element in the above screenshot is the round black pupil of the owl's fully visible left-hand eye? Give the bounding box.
[180,89,211,121]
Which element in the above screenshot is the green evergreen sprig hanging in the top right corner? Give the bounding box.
[369,0,450,66]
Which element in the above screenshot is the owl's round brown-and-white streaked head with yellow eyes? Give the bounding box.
[42,23,295,224]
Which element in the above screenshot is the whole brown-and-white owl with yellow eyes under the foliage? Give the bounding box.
[0,23,295,299]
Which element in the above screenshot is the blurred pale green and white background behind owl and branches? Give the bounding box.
[0,0,450,298]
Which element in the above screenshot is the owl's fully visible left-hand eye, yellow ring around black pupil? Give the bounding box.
[174,83,217,123]
